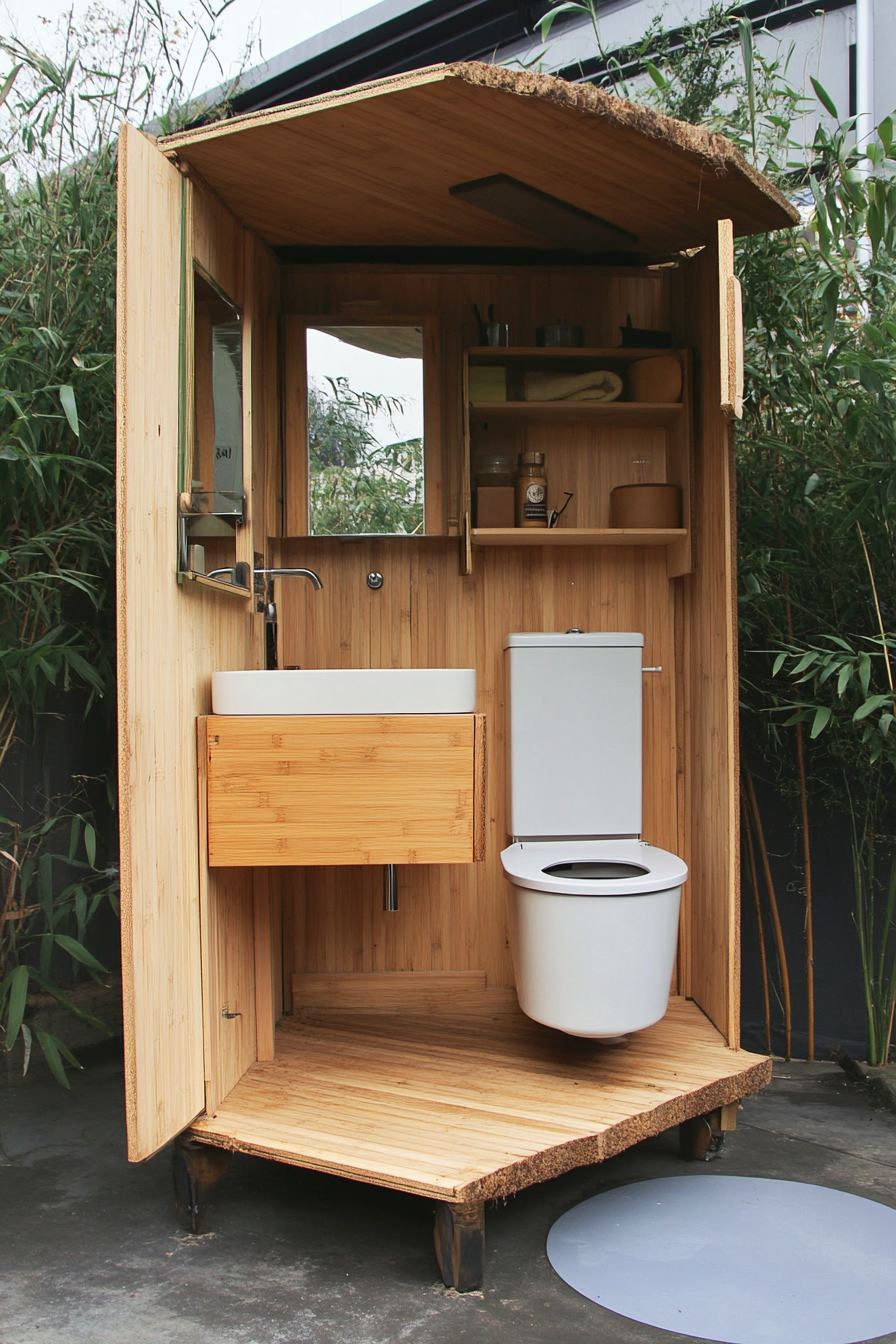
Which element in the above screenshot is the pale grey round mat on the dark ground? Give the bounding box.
[548,1172,896,1344]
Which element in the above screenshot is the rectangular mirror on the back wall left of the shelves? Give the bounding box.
[306,327,423,536]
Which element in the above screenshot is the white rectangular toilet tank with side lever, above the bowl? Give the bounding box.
[504,632,643,839]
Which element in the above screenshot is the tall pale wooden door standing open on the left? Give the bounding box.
[118,126,263,1161]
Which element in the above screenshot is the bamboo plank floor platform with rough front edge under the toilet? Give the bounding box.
[191,999,771,1202]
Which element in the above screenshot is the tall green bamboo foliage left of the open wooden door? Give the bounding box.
[0,0,245,1082]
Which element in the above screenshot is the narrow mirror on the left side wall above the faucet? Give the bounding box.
[187,273,244,536]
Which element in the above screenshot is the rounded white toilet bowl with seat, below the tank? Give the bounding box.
[501,840,688,1040]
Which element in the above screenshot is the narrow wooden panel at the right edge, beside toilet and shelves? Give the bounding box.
[673,219,743,1047]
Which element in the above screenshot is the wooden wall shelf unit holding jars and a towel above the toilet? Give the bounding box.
[463,345,693,578]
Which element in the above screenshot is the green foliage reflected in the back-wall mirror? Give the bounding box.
[308,378,423,536]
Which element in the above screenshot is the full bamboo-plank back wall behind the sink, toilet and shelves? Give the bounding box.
[277,266,689,986]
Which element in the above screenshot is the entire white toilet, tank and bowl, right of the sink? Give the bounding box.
[501,632,688,1040]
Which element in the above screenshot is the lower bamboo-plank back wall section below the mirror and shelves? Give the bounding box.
[281,539,678,986]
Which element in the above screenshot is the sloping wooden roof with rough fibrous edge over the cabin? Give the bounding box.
[160,62,798,259]
